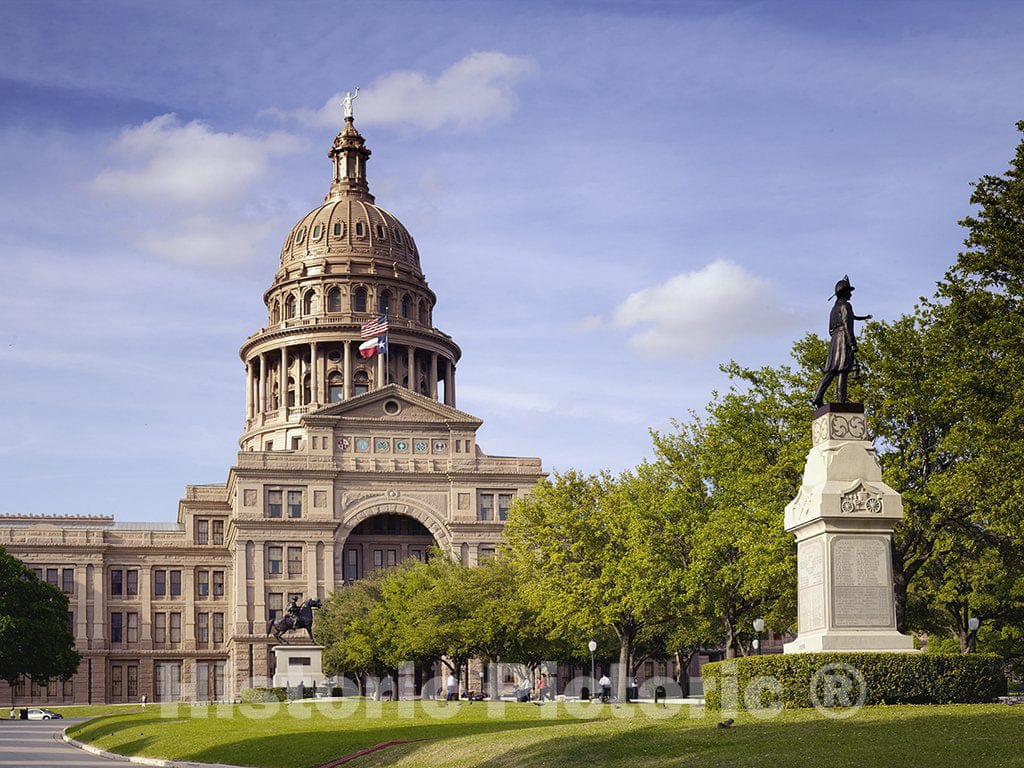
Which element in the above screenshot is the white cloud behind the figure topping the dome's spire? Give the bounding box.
[271,51,536,130]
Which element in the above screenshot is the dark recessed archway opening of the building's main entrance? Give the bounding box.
[342,512,438,584]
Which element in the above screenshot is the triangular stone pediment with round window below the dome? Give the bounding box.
[306,384,483,429]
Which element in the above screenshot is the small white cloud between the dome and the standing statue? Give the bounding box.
[611,259,800,357]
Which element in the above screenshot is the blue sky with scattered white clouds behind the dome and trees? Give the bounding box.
[0,0,1024,520]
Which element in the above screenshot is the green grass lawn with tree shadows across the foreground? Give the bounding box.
[71,699,1024,768]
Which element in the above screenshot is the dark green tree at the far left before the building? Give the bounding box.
[0,547,81,705]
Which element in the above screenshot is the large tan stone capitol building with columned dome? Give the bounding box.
[0,115,543,705]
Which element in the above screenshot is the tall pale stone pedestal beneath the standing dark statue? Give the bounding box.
[783,402,913,653]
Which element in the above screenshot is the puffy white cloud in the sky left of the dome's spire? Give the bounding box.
[92,115,299,206]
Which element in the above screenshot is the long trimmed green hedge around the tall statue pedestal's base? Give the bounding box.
[702,653,1007,711]
